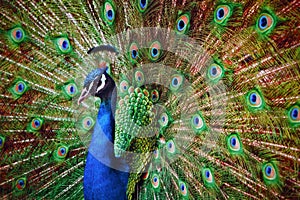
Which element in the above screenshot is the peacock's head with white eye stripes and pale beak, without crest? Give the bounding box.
[78,68,115,104]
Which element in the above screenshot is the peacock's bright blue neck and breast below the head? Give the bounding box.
[84,100,129,199]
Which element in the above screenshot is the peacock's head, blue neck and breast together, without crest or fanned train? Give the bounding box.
[78,64,129,200]
